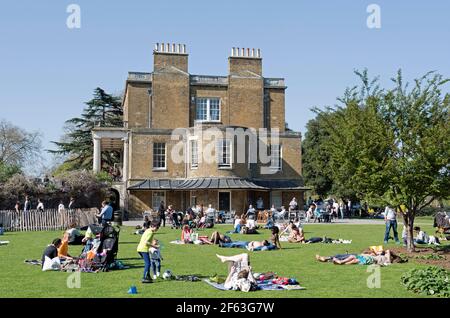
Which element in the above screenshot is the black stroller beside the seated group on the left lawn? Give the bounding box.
[90,225,120,272]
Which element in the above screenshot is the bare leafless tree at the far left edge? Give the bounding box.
[0,120,41,168]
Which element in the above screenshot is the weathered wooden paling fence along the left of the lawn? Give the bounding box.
[0,208,98,231]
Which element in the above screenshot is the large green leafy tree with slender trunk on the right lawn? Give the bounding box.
[316,71,450,251]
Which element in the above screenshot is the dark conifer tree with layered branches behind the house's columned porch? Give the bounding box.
[49,87,123,170]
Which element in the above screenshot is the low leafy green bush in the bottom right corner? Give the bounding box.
[401,266,450,297]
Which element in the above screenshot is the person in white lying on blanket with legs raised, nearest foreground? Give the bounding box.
[216,253,257,292]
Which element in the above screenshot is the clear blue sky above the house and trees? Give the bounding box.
[0,0,450,174]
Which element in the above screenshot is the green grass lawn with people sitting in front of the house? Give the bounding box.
[0,220,444,298]
